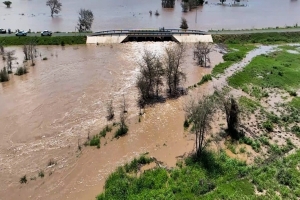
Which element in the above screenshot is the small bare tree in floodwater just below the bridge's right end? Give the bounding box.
[194,42,213,67]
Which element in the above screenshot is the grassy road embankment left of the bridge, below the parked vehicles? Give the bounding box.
[0,36,86,46]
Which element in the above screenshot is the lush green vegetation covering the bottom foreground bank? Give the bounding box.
[96,151,300,200]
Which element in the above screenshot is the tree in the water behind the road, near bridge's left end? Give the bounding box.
[77,9,94,32]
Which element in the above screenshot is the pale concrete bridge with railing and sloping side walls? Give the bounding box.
[86,28,213,44]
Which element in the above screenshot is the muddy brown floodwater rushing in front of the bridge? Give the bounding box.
[0,42,222,200]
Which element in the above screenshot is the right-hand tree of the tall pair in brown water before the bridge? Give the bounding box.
[164,44,186,96]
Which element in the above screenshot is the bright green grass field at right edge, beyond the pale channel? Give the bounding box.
[228,51,300,91]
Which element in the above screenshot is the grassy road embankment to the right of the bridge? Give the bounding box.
[212,32,300,44]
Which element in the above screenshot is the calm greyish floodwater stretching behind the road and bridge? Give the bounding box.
[0,0,300,31]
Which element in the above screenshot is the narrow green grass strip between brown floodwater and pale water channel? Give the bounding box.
[212,44,255,77]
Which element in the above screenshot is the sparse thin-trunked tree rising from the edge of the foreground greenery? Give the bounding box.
[186,96,215,157]
